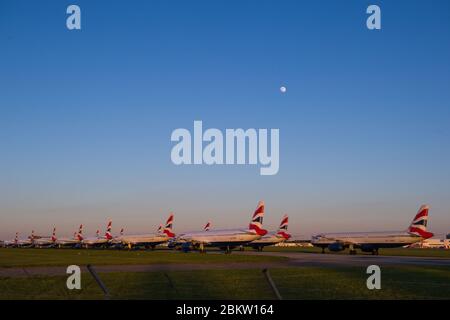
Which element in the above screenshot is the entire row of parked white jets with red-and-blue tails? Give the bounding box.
[0,201,433,254]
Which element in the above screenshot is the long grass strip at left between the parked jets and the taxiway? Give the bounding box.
[0,248,287,268]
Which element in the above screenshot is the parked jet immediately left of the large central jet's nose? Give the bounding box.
[117,213,175,250]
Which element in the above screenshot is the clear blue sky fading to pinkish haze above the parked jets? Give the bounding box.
[0,0,450,239]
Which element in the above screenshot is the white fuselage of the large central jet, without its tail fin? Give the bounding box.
[179,229,261,247]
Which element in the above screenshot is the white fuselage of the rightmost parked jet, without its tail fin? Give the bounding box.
[311,231,423,247]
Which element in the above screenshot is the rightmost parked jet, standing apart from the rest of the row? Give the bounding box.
[311,205,433,254]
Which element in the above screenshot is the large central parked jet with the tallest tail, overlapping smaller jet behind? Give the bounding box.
[179,201,267,253]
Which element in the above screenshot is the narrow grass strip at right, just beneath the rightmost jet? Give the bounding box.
[262,246,450,259]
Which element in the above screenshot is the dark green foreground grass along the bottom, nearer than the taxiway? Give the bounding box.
[0,267,450,299]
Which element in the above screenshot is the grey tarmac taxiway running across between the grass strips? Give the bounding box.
[0,251,450,278]
